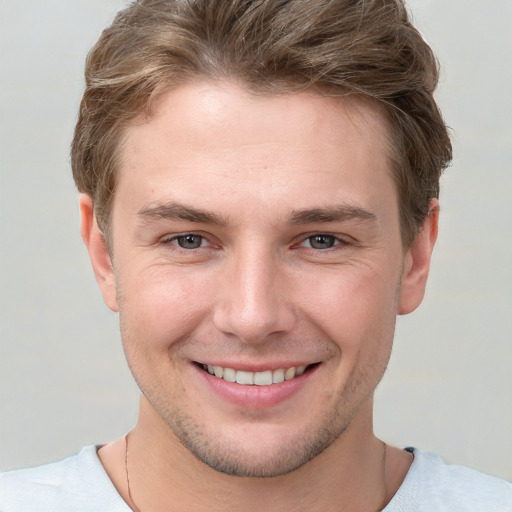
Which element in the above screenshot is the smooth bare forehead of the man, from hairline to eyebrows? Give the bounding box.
[115,83,396,222]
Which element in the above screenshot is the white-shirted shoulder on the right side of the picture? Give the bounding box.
[385,449,512,512]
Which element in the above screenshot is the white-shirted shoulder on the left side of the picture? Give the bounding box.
[0,446,130,512]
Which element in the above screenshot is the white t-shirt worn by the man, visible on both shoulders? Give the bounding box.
[0,446,512,512]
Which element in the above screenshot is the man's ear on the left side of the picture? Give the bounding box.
[80,194,119,311]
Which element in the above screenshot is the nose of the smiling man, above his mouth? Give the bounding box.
[214,246,295,343]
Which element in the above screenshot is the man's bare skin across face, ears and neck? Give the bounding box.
[80,83,438,511]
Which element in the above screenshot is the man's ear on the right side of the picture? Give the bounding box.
[398,199,439,315]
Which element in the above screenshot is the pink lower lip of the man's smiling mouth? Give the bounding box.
[196,365,319,409]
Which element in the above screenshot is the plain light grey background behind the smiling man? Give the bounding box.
[0,0,512,480]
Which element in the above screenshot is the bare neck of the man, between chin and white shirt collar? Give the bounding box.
[100,402,410,512]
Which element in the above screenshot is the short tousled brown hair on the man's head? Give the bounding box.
[71,0,451,246]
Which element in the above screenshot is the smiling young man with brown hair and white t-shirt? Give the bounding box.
[0,0,512,512]
